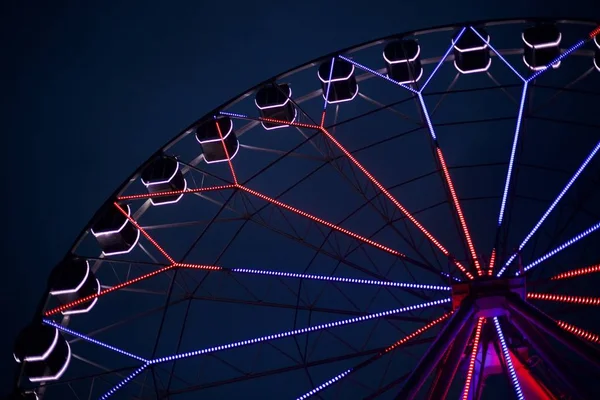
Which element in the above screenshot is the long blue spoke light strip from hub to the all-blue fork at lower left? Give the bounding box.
[149,298,451,364]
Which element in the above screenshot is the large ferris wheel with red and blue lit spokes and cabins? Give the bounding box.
[14,19,600,400]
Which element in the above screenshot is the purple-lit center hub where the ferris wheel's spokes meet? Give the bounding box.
[452,276,525,317]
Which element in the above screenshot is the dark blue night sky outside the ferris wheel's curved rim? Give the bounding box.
[0,0,600,398]
